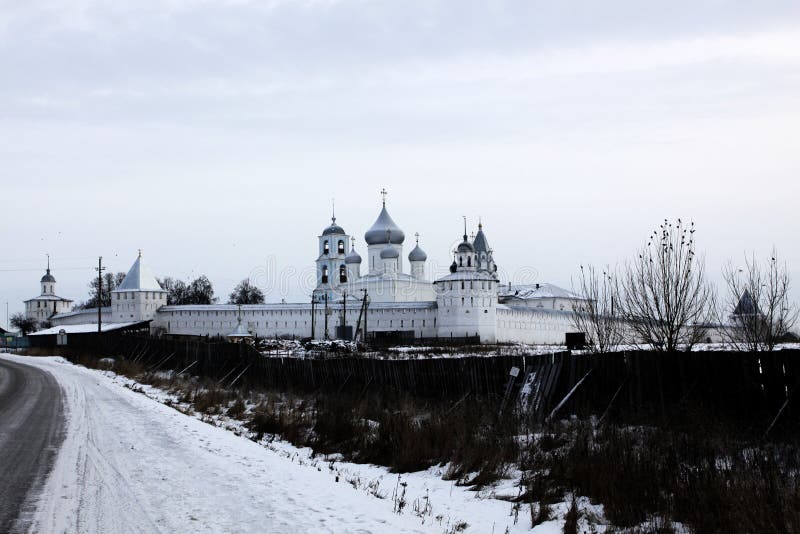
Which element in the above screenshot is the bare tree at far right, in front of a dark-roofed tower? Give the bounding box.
[719,248,800,352]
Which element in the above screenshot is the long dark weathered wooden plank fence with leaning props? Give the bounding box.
[57,334,800,432]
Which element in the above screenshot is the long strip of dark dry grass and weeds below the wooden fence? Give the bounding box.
[61,356,800,534]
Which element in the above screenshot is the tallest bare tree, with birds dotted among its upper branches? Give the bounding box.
[618,219,713,352]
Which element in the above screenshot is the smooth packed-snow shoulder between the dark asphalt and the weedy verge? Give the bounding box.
[0,355,432,533]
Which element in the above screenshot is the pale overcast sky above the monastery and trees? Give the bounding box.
[0,0,800,323]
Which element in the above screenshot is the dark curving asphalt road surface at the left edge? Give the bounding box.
[0,359,63,532]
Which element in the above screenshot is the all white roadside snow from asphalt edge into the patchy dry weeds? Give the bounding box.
[4,356,566,534]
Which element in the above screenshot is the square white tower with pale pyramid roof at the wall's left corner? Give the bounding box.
[111,250,167,323]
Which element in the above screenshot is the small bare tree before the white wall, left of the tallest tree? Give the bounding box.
[572,265,623,353]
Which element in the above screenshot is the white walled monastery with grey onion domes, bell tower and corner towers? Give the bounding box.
[28,193,582,344]
